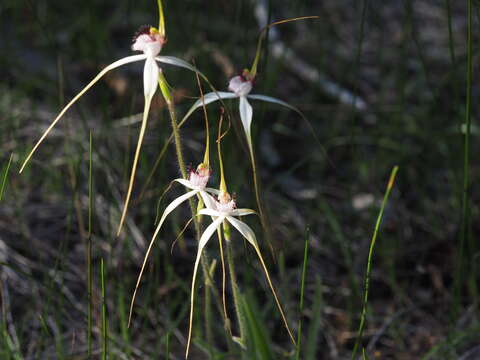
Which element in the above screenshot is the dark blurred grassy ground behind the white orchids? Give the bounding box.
[0,0,480,360]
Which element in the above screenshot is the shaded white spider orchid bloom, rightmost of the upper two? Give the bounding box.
[182,69,301,154]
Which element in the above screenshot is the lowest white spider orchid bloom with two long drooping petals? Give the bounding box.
[186,190,295,357]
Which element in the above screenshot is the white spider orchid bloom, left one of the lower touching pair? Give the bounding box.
[128,163,219,323]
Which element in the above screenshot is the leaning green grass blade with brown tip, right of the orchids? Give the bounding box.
[352,166,398,360]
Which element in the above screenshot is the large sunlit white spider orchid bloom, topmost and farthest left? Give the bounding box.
[20,19,204,235]
